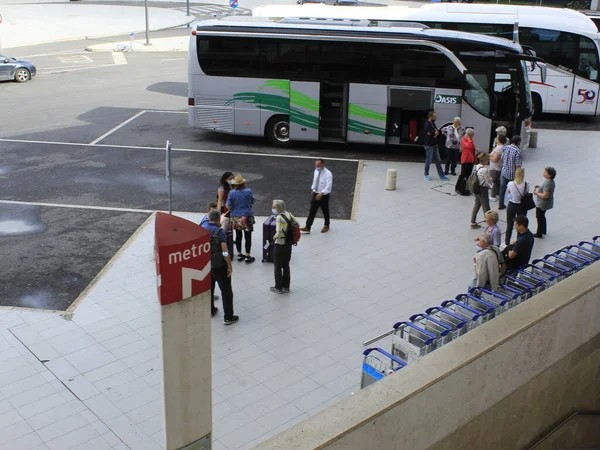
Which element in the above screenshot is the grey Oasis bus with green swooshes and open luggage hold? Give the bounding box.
[188,17,532,148]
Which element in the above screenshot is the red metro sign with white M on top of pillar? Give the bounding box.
[154,212,210,305]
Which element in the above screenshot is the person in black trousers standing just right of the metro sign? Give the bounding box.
[202,209,240,325]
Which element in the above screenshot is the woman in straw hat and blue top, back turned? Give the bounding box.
[226,173,256,264]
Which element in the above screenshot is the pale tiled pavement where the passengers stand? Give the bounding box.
[0,130,600,450]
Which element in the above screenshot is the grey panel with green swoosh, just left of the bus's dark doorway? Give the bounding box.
[290,81,319,141]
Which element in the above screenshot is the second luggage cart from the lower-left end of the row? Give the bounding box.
[392,322,437,363]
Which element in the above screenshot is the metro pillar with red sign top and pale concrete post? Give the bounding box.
[154,212,212,450]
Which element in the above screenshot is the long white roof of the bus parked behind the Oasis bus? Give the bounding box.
[252,3,598,38]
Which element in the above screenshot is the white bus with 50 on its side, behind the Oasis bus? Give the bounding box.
[252,3,600,115]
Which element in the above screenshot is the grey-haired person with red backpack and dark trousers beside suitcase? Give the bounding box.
[271,200,298,294]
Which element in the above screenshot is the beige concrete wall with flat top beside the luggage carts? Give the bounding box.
[255,263,600,450]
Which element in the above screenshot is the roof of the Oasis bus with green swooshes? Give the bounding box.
[195,16,523,53]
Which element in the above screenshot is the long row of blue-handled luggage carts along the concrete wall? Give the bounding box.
[361,236,600,388]
